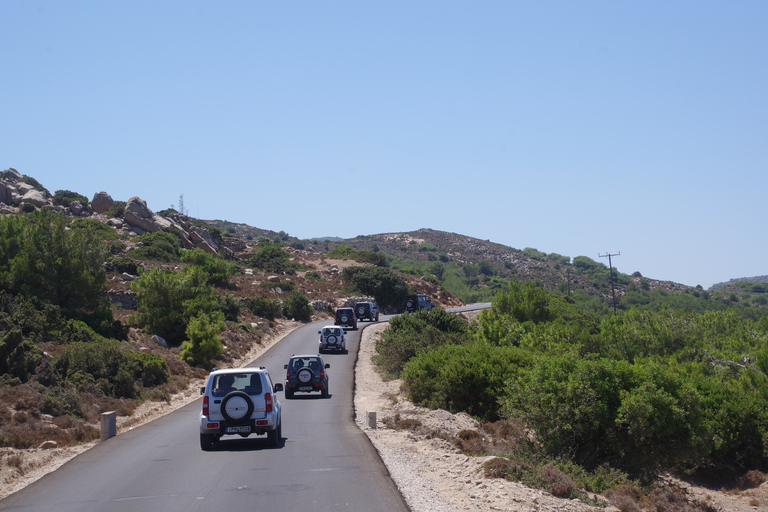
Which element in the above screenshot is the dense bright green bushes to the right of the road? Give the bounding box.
[376,281,768,510]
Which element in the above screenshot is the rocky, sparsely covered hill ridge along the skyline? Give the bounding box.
[0,168,760,308]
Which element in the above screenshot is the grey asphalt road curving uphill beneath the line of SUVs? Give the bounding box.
[0,321,408,512]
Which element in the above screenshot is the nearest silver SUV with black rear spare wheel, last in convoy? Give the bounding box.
[200,367,283,450]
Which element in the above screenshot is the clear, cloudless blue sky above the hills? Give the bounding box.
[0,0,768,288]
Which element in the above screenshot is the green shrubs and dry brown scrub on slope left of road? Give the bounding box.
[0,210,320,448]
